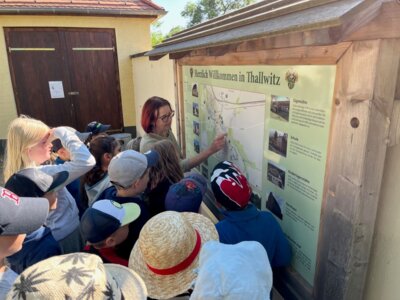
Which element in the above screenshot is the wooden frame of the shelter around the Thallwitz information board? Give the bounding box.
[148,0,400,300]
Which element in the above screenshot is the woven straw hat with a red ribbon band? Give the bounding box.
[129,211,218,299]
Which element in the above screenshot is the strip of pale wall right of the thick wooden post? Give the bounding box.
[364,141,400,300]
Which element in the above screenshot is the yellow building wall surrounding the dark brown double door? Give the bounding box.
[0,16,154,139]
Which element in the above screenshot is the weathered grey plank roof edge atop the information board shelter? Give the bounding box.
[146,0,381,59]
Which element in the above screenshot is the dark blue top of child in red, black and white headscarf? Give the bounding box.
[216,204,292,268]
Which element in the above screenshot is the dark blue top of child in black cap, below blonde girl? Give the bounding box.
[7,226,62,274]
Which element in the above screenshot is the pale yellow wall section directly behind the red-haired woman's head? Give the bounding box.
[132,55,176,135]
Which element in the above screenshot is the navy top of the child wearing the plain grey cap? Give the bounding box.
[97,186,150,259]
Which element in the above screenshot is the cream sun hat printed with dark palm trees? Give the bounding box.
[7,253,147,300]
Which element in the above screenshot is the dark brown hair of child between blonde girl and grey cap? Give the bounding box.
[81,134,119,205]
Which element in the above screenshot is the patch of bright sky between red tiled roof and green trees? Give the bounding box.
[152,0,191,34]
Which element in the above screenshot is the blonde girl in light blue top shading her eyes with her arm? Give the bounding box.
[4,116,95,253]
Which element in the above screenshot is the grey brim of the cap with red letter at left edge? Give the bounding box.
[0,197,49,235]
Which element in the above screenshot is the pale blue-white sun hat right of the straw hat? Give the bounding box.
[190,241,272,300]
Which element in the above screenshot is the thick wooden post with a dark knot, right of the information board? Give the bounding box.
[314,39,400,300]
